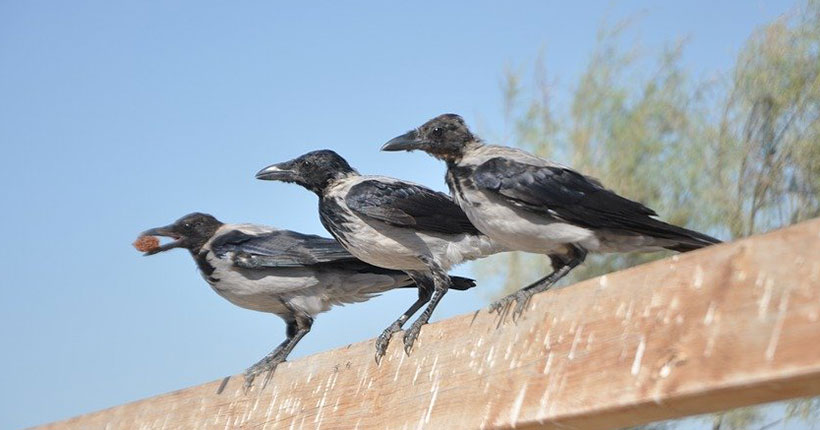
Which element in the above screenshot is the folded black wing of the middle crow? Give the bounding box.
[345,180,480,234]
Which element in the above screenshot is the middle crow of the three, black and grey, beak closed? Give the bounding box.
[256,150,504,361]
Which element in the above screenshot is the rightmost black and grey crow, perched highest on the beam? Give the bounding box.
[382,114,720,316]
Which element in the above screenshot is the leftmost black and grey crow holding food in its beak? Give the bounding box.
[142,213,474,388]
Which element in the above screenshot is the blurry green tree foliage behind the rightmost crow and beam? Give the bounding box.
[479,0,820,430]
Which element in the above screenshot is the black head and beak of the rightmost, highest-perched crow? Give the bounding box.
[382,113,476,161]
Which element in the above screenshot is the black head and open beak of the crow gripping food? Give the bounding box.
[142,212,222,255]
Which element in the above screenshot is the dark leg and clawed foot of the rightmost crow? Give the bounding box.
[490,245,587,320]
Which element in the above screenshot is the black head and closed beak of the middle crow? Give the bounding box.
[256,149,356,196]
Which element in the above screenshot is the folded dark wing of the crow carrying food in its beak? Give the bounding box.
[211,230,359,268]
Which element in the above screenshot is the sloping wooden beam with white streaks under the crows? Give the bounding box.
[38,220,820,429]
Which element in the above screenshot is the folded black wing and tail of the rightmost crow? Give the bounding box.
[472,157,719,243]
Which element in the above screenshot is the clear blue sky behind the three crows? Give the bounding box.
[0,0,793,428]
